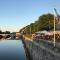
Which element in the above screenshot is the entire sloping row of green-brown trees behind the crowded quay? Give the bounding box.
[20,13,54,34]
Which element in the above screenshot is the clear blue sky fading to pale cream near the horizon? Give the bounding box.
[0,0,60,32]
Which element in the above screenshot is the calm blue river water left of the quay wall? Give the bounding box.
[0,40,26,60]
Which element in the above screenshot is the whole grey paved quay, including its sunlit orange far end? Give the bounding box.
[25,36,60,60]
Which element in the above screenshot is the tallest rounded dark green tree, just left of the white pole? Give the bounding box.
[38,13,54,30]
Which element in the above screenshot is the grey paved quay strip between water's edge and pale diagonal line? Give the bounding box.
[26,41,60,60]
